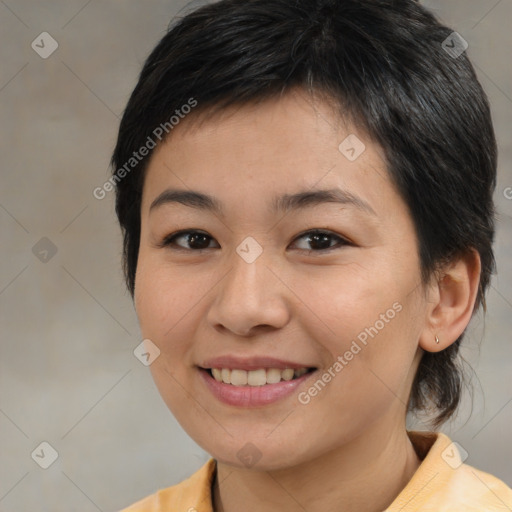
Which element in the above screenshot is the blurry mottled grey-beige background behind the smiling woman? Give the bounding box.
[0,0,512,512]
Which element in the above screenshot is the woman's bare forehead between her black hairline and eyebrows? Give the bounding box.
[143,93,397,220]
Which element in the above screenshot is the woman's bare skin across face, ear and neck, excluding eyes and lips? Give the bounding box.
[134,90,480,512]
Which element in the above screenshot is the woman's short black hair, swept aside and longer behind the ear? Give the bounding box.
[111,0,497,426]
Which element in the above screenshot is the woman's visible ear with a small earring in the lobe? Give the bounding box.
[419,249,481,352]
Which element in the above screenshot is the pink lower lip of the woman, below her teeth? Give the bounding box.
[199,368,315,407]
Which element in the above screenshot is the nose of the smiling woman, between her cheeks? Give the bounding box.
[207,246,291,337]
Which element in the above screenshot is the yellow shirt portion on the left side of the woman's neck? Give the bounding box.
[120,459,216,512]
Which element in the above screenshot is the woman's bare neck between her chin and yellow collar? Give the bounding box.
[213,422,420,512]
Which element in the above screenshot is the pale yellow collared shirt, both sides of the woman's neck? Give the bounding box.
[121,432,512,512]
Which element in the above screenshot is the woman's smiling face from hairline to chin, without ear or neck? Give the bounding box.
[135,93,428,469]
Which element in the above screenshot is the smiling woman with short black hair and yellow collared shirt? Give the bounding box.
[111,0,512,512]
